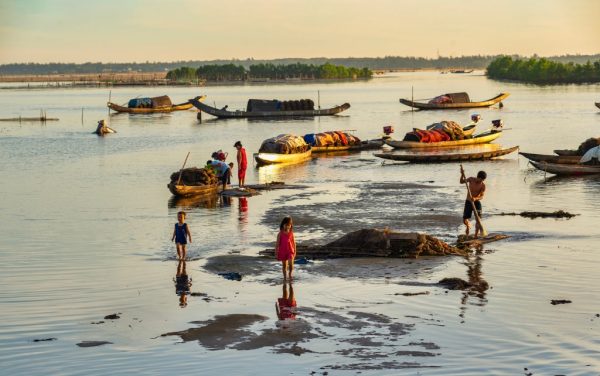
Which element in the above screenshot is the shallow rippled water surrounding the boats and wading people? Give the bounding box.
[0,72,600,375]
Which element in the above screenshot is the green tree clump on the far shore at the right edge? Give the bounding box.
[487,56,600,84]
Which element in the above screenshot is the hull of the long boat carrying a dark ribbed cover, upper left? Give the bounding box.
[190,97,350,119]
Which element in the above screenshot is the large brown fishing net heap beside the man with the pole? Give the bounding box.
[278,229,466,259]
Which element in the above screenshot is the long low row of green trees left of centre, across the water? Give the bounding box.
[167,63,373,81]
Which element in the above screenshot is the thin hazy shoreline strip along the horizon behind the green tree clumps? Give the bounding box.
[0,54,600,75]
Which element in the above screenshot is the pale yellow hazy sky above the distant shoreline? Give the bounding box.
[0,0,600,64]
